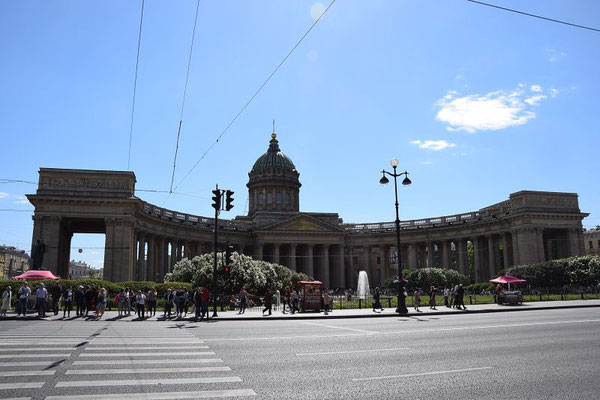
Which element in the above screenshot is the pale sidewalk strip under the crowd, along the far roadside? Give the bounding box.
[0,300,600,322]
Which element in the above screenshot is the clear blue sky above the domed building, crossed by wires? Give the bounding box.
[0,0,600,266]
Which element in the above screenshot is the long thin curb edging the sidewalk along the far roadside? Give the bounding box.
[0,304,600,322]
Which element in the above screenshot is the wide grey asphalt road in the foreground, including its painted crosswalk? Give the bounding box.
[0,308,600,400]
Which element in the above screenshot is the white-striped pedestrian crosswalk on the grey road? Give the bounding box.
[0,321,257,400]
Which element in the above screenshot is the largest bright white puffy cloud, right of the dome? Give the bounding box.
[435,83,558,133]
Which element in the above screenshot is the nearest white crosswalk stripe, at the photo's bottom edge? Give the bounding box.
[46,389,256,400]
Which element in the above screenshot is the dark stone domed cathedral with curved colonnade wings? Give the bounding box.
[27,134,587,288]
